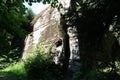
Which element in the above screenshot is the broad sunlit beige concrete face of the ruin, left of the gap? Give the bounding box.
[23,6,60,59]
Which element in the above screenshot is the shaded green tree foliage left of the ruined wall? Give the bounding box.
[0,0,34,69]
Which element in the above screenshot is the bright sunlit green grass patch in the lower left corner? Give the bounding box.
[0,62,27,80]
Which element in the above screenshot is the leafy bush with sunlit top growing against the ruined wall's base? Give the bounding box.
[25,47,61,80]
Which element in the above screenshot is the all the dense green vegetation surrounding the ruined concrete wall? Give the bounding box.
[0,0,120,80]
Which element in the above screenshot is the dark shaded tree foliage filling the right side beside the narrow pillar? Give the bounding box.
[62,0,120,80]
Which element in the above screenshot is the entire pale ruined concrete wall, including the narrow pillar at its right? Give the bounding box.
[23,0,80,71]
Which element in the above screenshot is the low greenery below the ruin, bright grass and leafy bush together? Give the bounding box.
[0,47,62,80]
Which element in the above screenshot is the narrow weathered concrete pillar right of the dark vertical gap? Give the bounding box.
[68,27,81,72]
